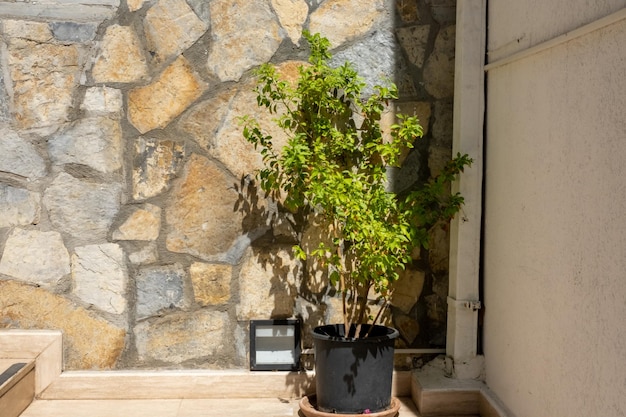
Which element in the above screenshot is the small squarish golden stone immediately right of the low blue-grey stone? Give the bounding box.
[189,262,233,306]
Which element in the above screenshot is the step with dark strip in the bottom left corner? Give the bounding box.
[0,359,35,417]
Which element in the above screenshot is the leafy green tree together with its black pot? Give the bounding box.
[242,32,472,414]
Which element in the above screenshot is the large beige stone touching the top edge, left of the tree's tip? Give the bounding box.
[207,0,283,81]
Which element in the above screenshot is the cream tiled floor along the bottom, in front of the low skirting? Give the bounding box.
[21,397,419,417]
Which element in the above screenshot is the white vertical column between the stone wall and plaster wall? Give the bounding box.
[446,0,487,379]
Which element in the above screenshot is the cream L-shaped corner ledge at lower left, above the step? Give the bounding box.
[0,330,63,396]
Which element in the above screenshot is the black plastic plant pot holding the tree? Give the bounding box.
[313,324,399,414]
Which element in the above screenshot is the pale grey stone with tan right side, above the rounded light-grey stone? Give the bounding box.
[48,117,122,173]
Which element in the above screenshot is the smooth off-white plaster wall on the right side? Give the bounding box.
[483,4,626,417]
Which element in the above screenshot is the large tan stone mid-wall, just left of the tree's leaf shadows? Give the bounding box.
[165,154,244,259]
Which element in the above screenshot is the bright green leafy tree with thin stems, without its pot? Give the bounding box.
[242,31,472,336]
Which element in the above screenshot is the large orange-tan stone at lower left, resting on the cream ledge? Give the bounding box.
[0,281,126,369]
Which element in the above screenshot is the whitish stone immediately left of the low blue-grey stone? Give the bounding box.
[72,243,128,314]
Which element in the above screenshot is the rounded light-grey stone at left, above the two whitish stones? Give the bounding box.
[44,172,122,243]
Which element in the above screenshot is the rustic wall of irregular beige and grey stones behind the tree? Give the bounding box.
[0,0,455,369]
